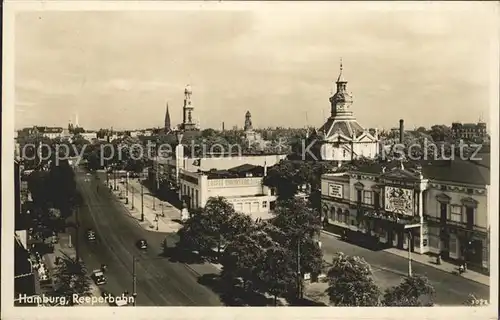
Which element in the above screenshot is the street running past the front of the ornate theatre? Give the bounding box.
[321,234,490,305]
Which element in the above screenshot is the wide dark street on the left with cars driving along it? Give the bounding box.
[76,168,221,306]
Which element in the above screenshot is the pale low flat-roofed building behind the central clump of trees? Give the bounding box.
[179,164,276,219]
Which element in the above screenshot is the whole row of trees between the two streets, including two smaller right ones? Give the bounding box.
[178,197,440,306]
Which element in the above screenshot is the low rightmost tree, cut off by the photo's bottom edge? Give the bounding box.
[383,275,435,307]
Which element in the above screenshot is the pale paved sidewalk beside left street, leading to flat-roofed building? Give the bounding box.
[110,179,182,233]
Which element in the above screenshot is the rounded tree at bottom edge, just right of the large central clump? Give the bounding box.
[326,253,380,307]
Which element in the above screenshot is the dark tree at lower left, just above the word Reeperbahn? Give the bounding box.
[54,255,92,301]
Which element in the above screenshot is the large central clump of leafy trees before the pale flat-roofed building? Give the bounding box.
[178,197,323,300]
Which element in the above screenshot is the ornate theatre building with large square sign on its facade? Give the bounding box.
[321,160,489,270]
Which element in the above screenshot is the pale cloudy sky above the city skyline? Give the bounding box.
[15,2,498,129]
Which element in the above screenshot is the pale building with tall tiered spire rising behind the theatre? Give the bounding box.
[315,62,379,161]
